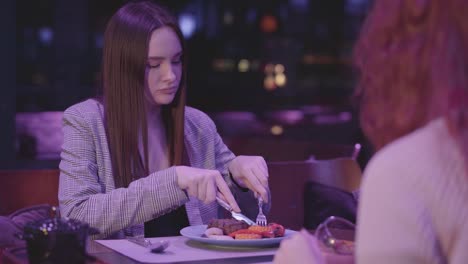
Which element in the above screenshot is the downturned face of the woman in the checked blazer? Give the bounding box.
[145,27,182,106]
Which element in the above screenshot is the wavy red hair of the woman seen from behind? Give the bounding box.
[354,0,468,152]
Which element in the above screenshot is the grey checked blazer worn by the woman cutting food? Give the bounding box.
[58,99,256,239]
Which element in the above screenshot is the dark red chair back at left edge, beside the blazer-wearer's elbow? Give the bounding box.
[0,169,60,215]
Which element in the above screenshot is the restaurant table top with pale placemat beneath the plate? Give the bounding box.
[3,236,354,264]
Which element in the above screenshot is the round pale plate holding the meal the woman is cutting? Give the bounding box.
[180,225,296,247]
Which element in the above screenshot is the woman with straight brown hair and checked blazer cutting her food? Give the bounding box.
[59,1,269,238]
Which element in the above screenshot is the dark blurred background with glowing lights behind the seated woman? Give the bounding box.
[8,0,370,169]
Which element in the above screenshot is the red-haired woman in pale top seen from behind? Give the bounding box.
[276,0,468,263]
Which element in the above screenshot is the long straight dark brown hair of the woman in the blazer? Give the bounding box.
[102,1,186,188]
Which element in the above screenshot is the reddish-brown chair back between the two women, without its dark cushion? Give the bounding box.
[268,158,362,230]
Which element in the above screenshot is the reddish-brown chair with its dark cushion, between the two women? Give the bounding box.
[268,158,362,230]
